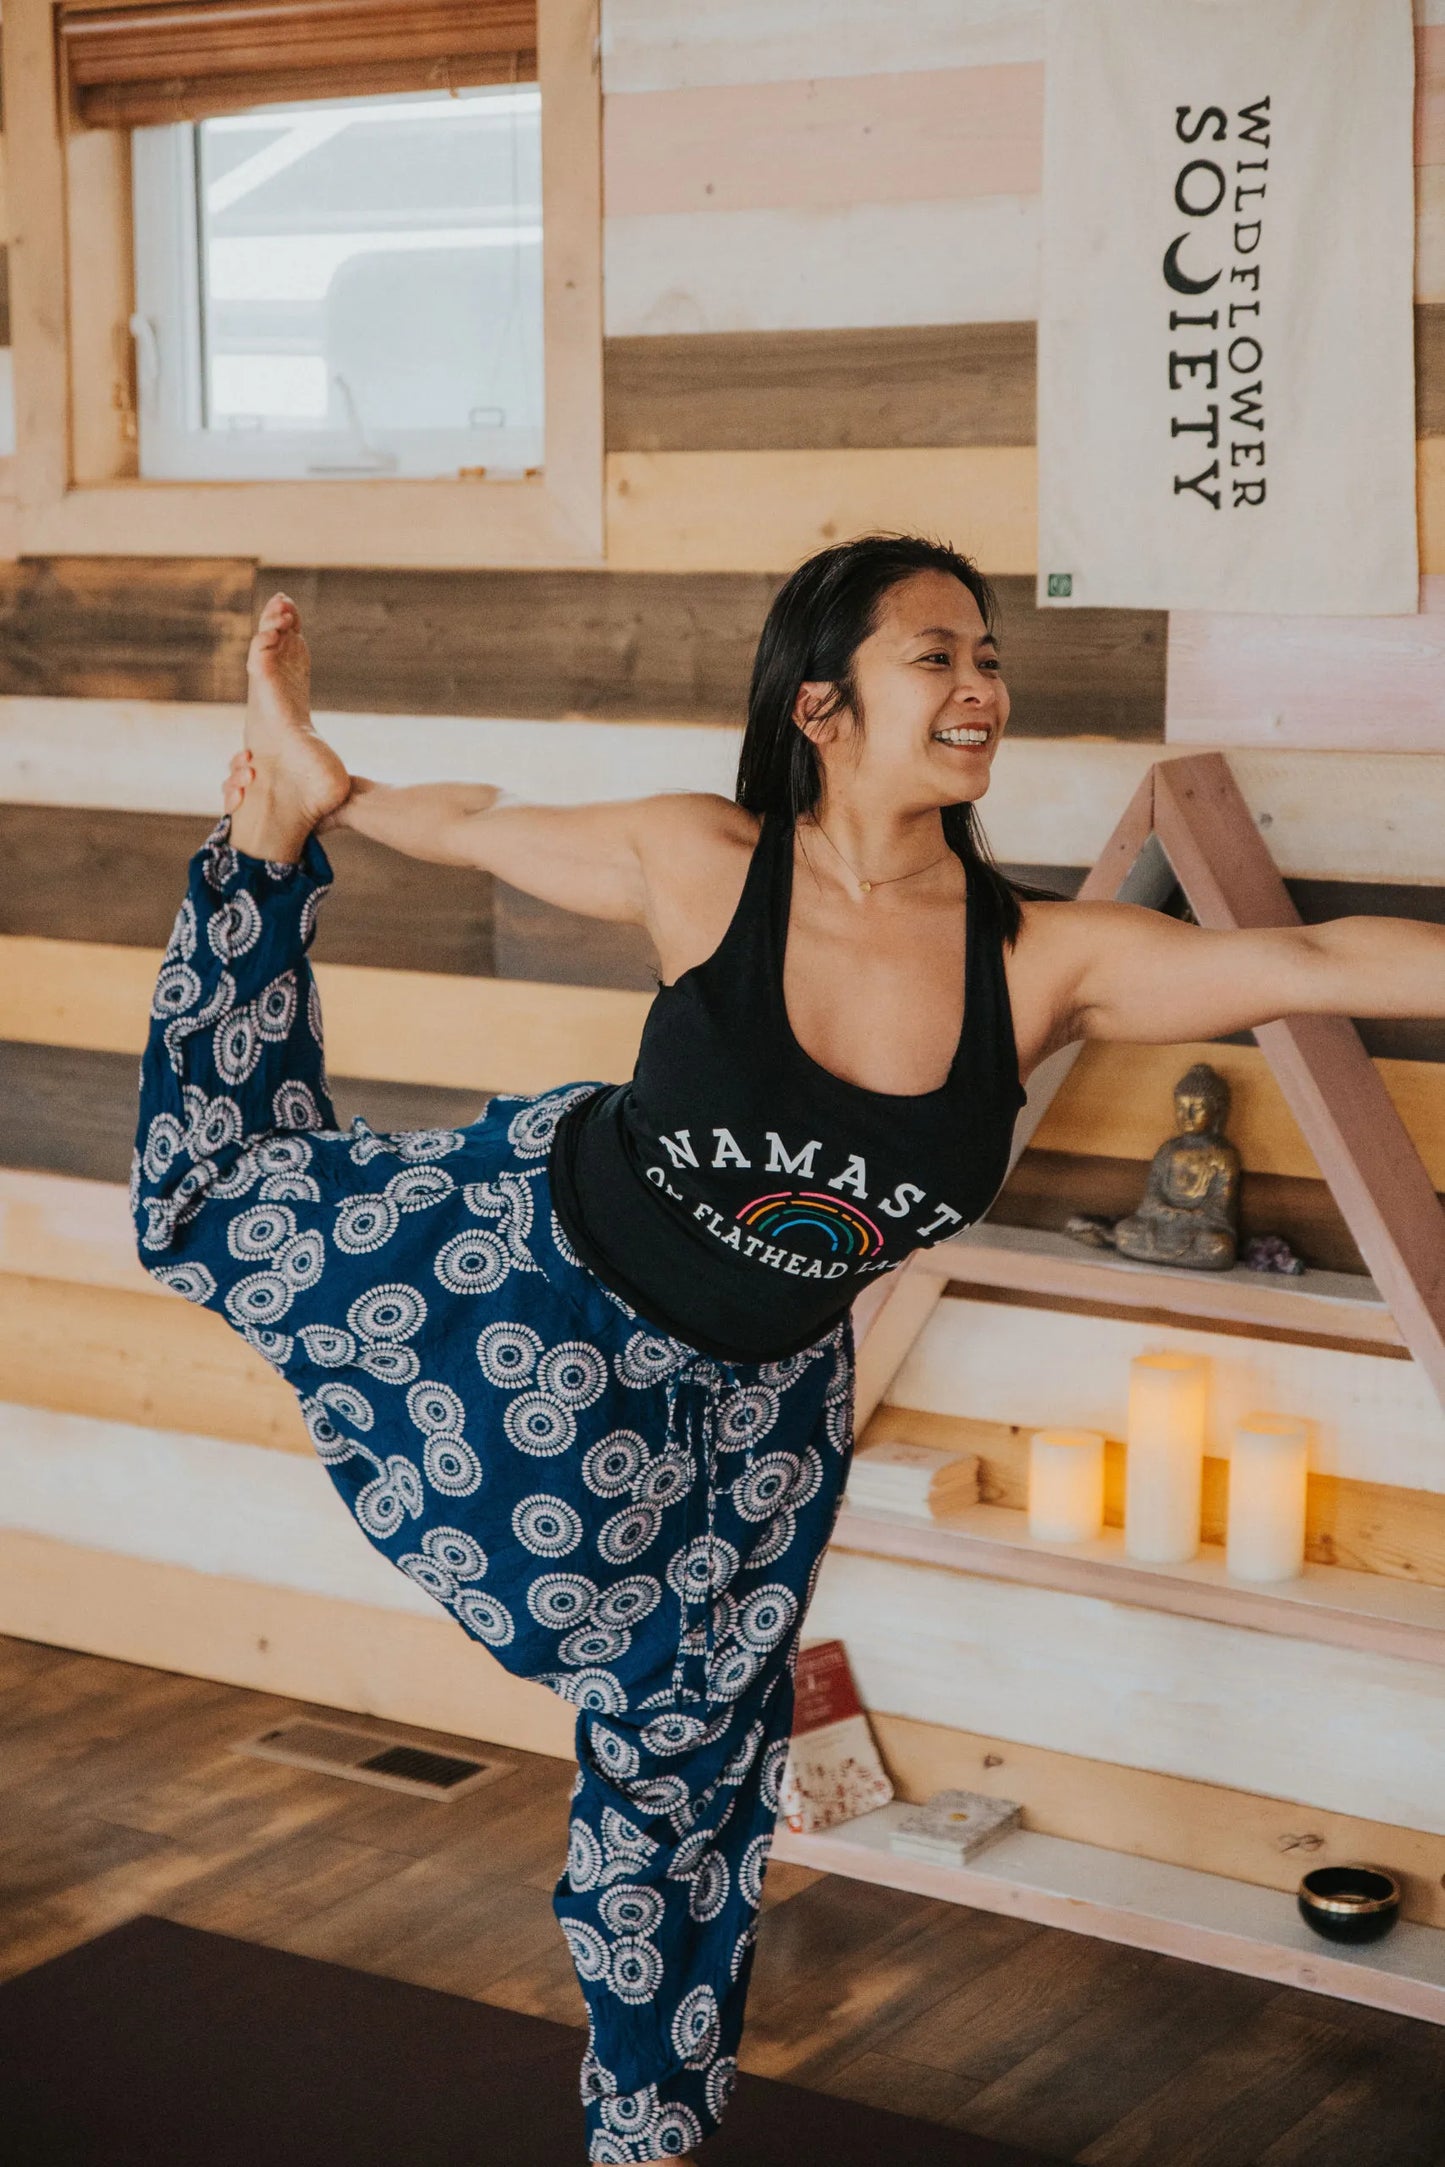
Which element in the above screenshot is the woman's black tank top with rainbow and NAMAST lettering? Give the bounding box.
[548,813,1025,1361]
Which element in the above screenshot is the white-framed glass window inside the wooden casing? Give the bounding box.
[132,85,544,481]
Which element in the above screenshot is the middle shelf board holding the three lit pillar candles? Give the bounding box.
[832,1499,1445,1664]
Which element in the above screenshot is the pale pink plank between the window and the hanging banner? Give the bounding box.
[602,60,1044,219]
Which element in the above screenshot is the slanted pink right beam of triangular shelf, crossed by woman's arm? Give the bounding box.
[1155,752,1445,1400]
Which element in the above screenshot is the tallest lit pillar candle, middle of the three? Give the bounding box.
[1124,1354,1209,1565]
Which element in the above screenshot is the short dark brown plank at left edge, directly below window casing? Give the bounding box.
[0,557,251,700]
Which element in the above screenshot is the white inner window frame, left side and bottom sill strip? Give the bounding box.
[130,94,544,481]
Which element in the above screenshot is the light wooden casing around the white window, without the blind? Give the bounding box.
[0,0,604,568]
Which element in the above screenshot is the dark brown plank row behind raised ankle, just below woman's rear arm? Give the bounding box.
[0,804,654,990]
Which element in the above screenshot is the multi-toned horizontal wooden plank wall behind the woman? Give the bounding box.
[0,0,1445,1880]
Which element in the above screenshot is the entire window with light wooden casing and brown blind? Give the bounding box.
[0,0,604,566]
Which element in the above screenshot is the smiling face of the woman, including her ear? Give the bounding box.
[793,572,1010,808]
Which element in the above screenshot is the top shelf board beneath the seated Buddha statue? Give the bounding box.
[919,1222,1404,1348]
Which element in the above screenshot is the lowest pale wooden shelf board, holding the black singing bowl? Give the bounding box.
[773,1801,1445,2024]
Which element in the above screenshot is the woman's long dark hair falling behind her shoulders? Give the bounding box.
[734,535,1044,947]
